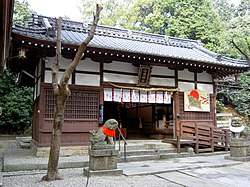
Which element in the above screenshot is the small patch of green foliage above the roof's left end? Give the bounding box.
[13,0,32,26]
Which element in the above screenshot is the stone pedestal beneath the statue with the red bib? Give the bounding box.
[84,149,123,176]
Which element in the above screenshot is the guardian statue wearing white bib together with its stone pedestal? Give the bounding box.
[225,117,250,161]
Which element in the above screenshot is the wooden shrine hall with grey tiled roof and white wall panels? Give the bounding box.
[7,15,249,155]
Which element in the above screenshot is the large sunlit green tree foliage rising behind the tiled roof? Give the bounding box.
[79,0,250,58]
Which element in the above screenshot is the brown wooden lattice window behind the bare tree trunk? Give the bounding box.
[44,90,99,119]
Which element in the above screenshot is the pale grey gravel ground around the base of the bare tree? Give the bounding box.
[3,168,180,187]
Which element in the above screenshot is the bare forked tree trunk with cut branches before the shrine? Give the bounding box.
[42,4,102,181]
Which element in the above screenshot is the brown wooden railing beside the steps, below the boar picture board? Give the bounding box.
[176,123,229,154]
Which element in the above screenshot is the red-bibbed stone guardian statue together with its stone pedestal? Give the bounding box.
[84,119,123,176]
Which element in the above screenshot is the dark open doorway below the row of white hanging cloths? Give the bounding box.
[104,101,174,139]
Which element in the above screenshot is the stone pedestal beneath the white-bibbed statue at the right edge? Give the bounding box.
[225,138,250,161]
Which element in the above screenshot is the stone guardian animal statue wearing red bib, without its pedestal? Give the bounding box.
[90,119,118,149]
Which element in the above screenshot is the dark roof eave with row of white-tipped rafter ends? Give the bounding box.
[10,26,249,75]
